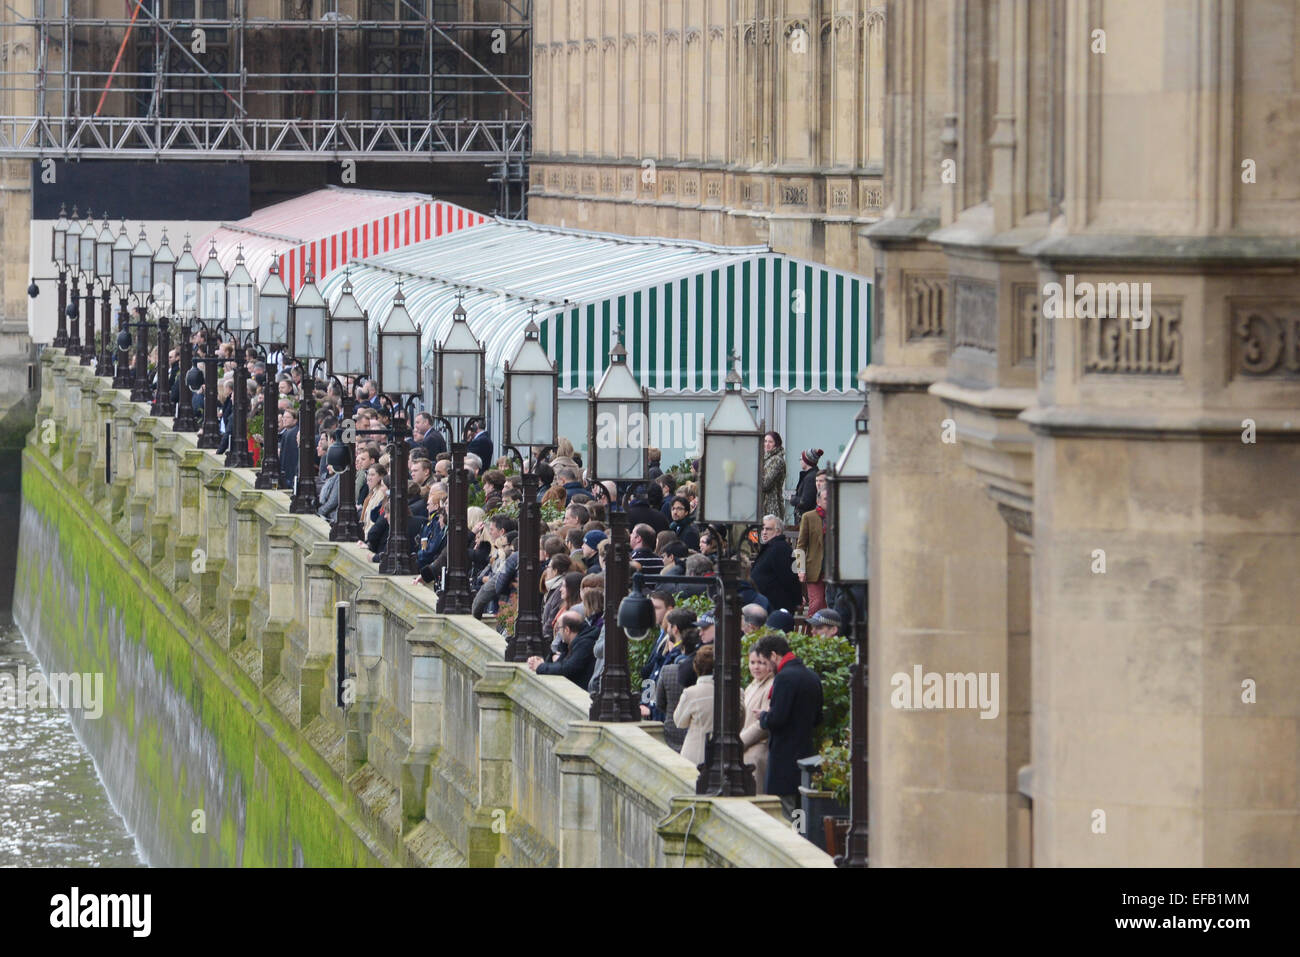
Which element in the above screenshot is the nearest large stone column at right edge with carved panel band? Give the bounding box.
[1024,0,1300,867]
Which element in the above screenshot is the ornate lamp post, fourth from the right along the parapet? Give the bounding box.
[506,319,556,662]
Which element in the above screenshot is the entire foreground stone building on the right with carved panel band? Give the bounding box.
[863,0,1300,867]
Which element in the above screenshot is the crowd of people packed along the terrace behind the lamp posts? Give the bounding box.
[152,334,845,810]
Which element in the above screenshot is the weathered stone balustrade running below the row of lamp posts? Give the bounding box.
[26,350,831,867]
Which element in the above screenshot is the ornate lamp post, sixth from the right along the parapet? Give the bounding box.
[378,285,420,575]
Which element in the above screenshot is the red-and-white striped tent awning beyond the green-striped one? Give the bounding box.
[195,186,488,294]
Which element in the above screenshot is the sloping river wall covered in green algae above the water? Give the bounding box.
[16,447,393,866]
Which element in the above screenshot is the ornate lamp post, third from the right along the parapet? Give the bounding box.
[588,328,650,722]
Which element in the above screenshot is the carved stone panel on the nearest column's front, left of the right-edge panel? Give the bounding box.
[1081,299,1183,376]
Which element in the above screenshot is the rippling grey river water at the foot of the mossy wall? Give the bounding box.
[0,624,144,867]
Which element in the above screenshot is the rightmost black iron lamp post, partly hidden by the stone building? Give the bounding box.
[826,390,871,867]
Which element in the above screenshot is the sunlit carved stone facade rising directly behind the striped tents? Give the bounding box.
[529,0,885,274]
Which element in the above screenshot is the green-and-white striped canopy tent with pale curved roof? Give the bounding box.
[321,220,871,394]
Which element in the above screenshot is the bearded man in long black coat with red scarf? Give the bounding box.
[754,635,822,817]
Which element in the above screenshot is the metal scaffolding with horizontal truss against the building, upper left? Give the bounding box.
[0,0,532,215]
